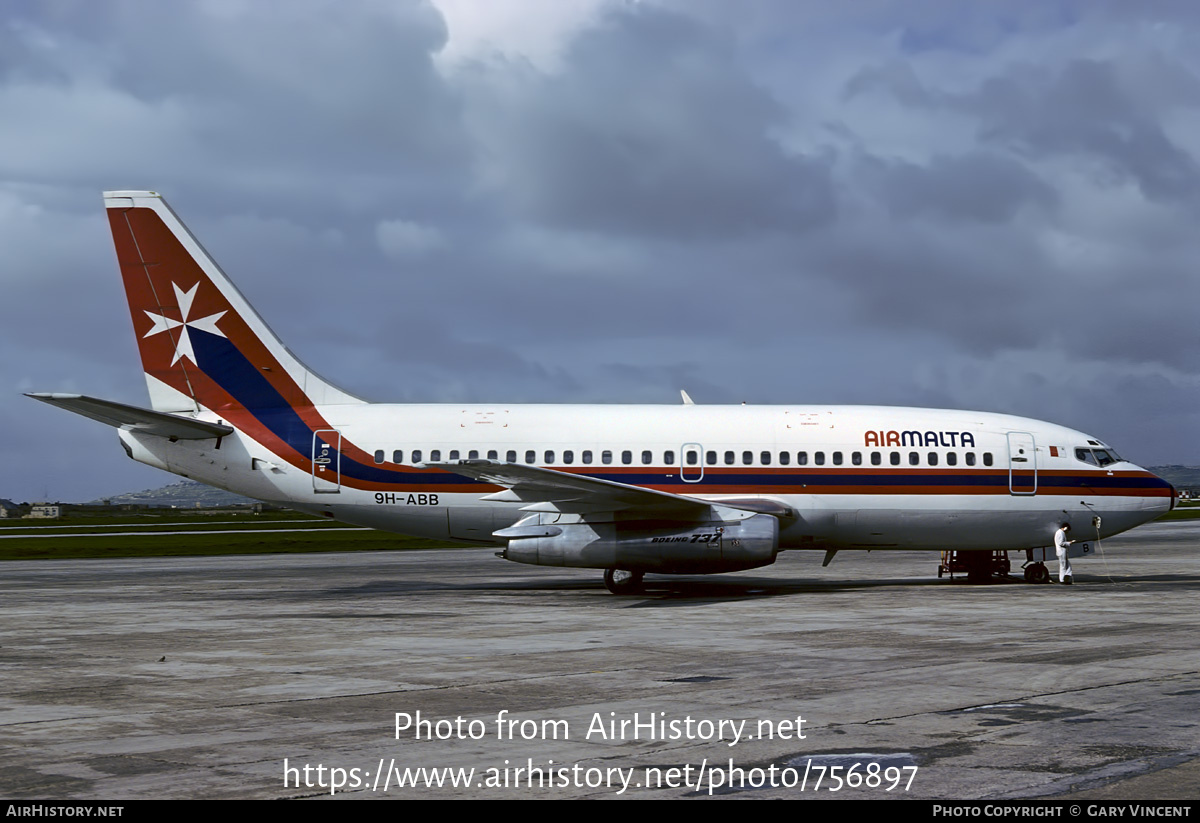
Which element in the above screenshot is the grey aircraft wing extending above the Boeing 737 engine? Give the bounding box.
[424,459,713,515]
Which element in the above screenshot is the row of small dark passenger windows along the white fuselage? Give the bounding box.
[374,449,992,465]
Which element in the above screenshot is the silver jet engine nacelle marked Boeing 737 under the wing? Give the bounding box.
[496,510,779,575]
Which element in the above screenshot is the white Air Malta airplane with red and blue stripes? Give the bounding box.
[29,191,1177,594]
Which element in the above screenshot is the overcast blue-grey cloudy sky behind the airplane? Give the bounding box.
[0,0,1200,500]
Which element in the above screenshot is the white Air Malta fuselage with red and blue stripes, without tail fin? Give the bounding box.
[122,404,1172,549]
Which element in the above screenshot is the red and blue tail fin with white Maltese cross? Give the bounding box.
[104,192,365,413]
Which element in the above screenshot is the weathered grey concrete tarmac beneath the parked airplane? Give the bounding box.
[0,521,1200,803]
